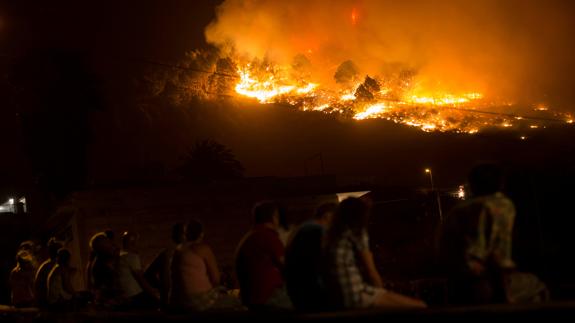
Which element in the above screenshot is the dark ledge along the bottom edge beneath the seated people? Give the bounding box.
[0,301,575,323]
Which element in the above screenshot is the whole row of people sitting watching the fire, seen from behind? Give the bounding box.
[10,165,548,311]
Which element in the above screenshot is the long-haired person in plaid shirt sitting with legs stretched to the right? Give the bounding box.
[325,198,426,309]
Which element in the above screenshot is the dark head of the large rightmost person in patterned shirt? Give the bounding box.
[468,163,503,196]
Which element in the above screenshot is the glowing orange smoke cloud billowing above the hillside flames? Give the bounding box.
[205,0,575,105]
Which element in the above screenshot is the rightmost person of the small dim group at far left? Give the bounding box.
[46,248,76,307]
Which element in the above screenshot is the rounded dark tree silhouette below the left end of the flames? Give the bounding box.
[180,139,244,183]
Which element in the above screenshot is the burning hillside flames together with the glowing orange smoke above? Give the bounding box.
[172,0,573,133]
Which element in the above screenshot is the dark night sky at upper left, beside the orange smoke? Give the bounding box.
[0,0,219,60]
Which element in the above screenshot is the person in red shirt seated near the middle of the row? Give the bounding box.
[236,202,291,309]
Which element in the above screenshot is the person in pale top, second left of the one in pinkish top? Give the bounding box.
[118,231,159,308]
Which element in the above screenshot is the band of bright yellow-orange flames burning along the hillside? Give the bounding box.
[228,59,573,134]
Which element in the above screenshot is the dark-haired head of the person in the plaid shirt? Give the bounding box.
[333,197,369,232]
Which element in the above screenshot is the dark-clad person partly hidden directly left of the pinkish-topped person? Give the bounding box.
[144,223,185,307]
